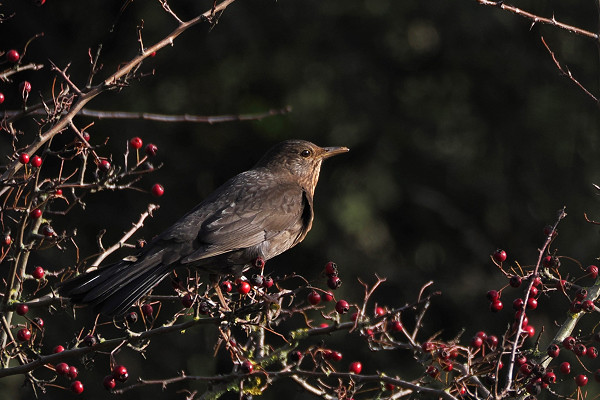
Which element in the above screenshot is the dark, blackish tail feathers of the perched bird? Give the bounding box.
[58,257,172,315]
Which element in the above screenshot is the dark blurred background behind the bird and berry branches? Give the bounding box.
[0,0,600,399]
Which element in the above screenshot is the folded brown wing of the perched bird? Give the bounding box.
[161,171,307,264]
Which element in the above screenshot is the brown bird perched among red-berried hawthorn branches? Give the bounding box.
[57,140,349,316]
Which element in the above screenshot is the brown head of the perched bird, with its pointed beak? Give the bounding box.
[255,140,348,194]
